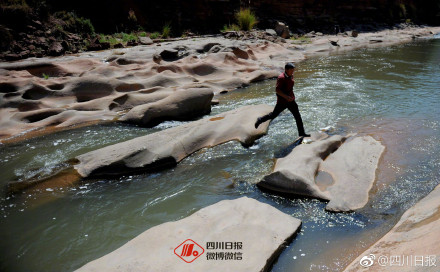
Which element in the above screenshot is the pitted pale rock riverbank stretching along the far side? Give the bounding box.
[0,24,440,143]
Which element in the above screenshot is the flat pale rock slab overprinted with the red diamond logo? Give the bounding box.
[77,197,301,272]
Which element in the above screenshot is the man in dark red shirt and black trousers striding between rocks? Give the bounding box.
[255,62,310,137]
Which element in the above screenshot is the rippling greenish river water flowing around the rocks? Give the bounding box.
[0,39,440,271]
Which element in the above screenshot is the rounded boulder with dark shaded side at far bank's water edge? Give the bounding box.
[119,88,214,127]
